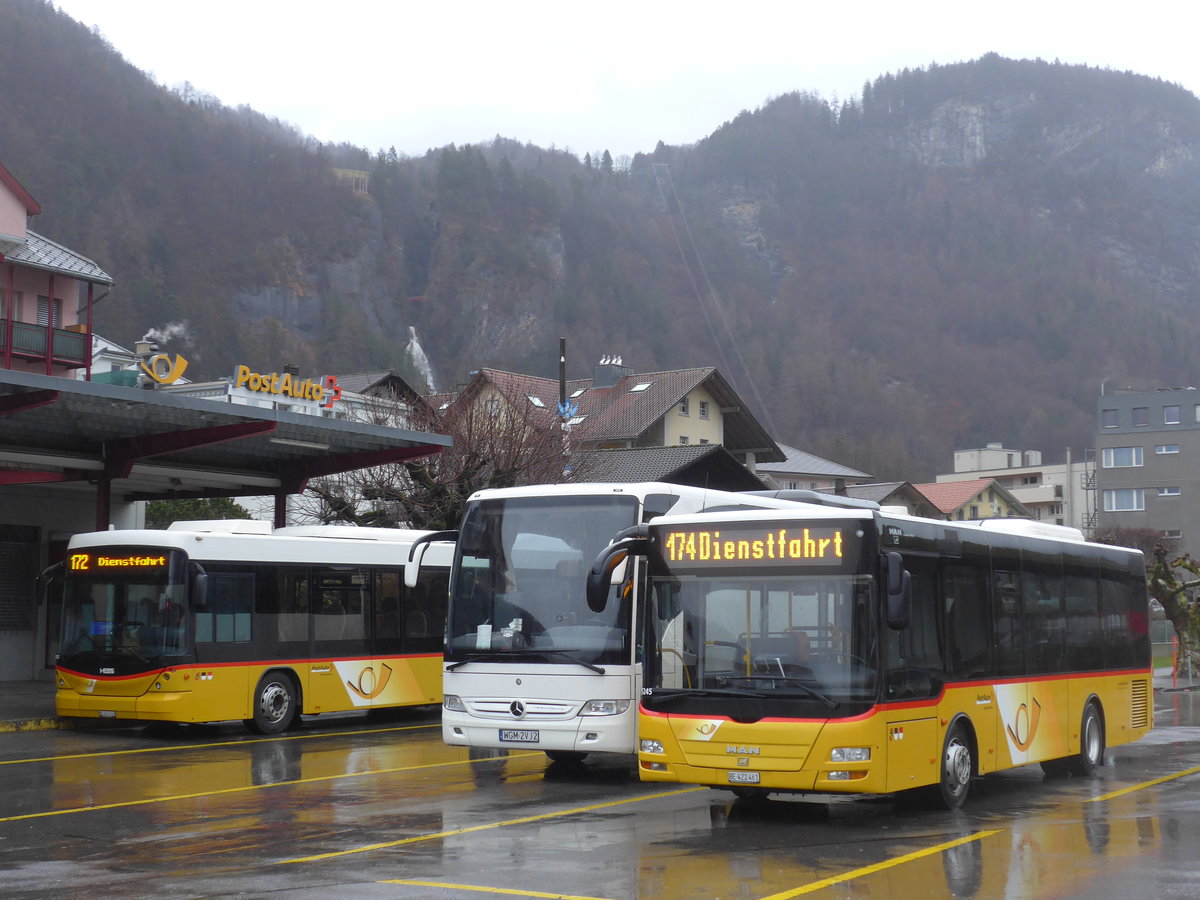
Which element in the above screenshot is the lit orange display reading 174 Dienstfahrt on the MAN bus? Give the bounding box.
[662,524,846,565]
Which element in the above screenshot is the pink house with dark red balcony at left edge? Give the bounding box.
[0,164,113,376]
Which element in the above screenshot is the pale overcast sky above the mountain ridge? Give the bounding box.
[51,0,1200,157]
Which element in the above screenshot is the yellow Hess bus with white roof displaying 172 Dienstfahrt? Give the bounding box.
[43,520,454,733]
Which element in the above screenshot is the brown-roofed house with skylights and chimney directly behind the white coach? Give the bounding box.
[451,358,786,472]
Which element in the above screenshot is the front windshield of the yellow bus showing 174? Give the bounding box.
[644,575,877,706]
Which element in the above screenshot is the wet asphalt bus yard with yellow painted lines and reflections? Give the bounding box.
[0,691,1200,900]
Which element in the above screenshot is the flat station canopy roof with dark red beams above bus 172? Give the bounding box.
[0,370,451,500]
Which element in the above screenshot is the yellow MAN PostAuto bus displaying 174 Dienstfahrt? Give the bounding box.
[588,494,1153,809]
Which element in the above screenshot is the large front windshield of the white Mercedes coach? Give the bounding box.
[445,494,638,665]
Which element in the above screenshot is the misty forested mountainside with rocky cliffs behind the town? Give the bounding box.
[0,0,1200,480]
